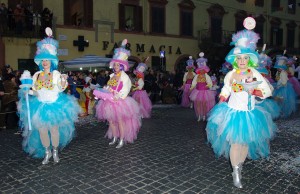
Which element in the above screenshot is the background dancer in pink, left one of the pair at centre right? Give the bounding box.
[181,56,196,108]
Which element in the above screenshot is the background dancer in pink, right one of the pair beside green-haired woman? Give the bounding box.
[190,52,216,121]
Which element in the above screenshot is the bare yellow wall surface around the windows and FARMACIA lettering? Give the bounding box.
[2,0,300,70]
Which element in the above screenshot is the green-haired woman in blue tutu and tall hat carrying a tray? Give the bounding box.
[206,17,277,188]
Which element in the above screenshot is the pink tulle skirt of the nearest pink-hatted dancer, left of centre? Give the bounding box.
[96,96,141,143]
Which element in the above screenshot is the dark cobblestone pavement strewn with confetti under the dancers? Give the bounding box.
[0,105,300,194]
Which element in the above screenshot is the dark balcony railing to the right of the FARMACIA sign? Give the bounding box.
[198,29,234,45]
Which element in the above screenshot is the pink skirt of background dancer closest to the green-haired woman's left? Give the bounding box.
[190,89,216,118]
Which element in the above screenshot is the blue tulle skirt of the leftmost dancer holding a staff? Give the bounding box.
[18,90,81,158]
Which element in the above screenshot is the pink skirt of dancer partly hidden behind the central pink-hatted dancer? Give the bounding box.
[132,90,152,118]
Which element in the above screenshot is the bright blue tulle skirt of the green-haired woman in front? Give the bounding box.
[206,103,277,159]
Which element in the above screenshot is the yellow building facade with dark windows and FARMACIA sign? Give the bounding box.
[0,0,300,71]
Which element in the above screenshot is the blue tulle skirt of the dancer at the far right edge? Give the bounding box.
[273,82,297,118]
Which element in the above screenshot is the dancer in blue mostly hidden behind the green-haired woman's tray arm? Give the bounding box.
[256,45,280,119]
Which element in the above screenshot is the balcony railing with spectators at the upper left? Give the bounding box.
[0,15,54,38]
